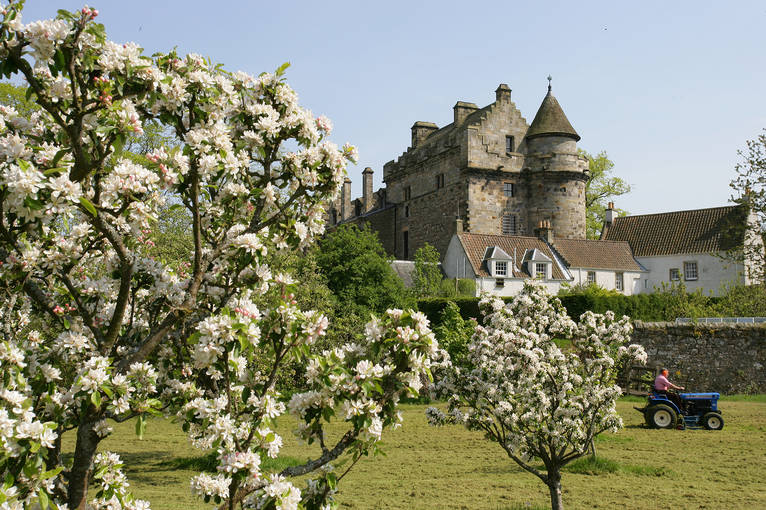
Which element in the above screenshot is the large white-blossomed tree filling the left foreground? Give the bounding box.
[0,1,438,509]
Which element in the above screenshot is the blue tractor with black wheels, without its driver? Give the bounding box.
[634,392,723,430]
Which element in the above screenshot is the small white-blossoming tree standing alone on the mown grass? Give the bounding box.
[427,283,646,510]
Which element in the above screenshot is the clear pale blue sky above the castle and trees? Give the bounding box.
[24,0,766,214]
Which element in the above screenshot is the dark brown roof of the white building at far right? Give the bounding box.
[601,205,747,257]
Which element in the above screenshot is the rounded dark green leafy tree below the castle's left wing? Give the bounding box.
[316,225,413,317]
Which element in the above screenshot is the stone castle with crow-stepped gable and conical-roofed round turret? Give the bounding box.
[329,84,588,259]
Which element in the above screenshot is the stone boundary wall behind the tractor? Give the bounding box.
[632,321,766,394]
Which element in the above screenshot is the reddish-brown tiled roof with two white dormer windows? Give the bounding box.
[458,232,568,280]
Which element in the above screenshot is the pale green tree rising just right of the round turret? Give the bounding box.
[579,149,630,239]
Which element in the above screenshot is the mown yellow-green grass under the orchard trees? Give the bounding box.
[65,395,766,510]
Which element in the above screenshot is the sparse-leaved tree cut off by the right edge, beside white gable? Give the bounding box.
[729,129,766,284]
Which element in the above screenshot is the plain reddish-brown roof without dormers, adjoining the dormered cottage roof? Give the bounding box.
[553,238,646,271]
